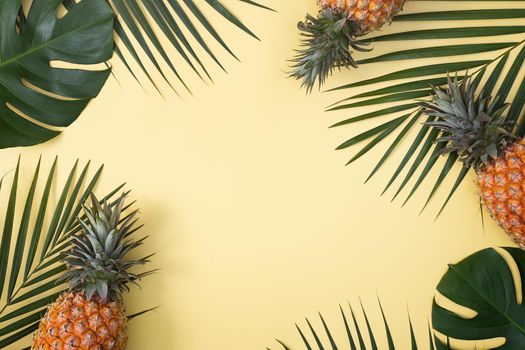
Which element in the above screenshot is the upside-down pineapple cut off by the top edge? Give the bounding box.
[290,0,406,92]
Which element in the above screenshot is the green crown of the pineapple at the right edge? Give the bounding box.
[421,74,516,169]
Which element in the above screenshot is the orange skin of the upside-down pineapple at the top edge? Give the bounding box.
[319,0,407,33]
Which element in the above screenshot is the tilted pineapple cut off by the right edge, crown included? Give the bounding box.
[422,76,525,249]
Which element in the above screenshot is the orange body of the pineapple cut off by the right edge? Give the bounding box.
[478,140,525,249]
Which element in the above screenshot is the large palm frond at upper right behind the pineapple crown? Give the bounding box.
[328,0,525,215]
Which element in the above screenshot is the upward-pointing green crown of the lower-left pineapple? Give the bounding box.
[61,194,153,301]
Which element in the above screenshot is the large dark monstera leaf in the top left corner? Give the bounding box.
[0,0,113,148]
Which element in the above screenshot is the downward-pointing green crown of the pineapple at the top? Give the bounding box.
[290,8,370,92]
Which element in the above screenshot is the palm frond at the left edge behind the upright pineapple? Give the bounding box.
[0,159,133,349]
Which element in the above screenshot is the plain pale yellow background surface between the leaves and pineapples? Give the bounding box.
[4,0,523,350]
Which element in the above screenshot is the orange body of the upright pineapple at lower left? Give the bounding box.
[32,292,127,350]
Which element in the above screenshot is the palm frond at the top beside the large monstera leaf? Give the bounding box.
[101,0,273,92]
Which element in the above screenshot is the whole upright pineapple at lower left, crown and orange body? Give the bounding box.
[32,195,151,350]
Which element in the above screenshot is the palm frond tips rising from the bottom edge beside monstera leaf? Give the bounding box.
[270,299,438,350]
